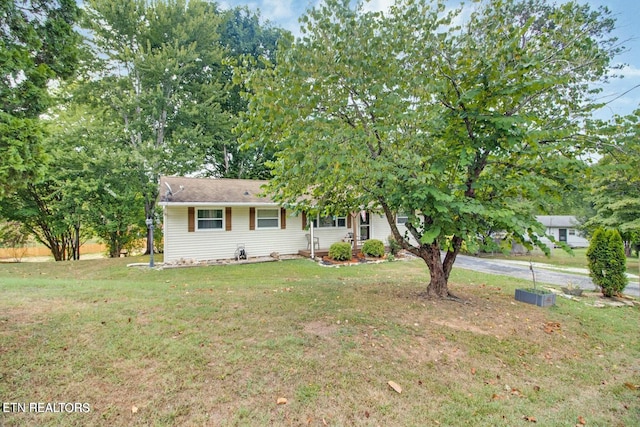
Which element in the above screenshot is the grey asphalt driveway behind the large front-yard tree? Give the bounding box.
[454,255,640,297]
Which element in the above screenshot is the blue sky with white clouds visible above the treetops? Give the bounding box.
[217,0,640,119]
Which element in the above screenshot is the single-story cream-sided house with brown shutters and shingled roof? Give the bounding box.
[159,176,406,262]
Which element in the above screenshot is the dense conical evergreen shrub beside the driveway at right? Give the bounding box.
[587,228,628,297]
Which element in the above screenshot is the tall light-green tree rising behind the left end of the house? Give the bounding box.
[85,0,231,252]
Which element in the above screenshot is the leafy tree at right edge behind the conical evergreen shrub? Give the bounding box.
[587,110,640,256]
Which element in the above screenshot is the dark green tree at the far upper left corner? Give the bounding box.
[0,0,80,197]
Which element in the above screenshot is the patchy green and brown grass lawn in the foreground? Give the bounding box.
[0,258,640,426]
